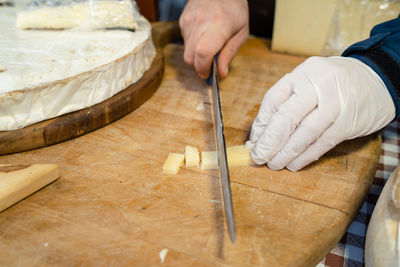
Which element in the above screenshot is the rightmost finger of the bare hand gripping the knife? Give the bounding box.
[218,28,249,78]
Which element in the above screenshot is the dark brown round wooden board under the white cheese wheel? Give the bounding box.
[0,22,179,155]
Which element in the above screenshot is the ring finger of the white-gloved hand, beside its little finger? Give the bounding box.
[268,105,336,170]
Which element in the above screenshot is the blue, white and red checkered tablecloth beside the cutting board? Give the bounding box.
[317,122,400,267]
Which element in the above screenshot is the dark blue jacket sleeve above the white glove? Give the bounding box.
[342,17,400,119]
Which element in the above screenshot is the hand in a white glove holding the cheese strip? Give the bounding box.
[249,57,395,171]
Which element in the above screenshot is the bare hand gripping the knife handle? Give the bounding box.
[179,0,249,79]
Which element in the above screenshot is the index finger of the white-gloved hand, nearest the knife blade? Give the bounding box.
[250,75,293,143]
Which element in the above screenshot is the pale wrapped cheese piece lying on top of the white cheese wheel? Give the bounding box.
[16,0,138,30]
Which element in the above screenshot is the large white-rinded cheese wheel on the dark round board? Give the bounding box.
[0,7,156,131]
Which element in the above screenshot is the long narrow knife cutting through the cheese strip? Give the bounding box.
[211,58,236,243]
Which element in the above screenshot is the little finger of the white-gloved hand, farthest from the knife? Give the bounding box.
[287,124,343,172]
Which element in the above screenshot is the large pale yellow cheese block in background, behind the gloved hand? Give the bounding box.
[272,0,400,56]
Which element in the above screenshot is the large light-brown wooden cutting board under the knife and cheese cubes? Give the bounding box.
[0,39,381,266]
